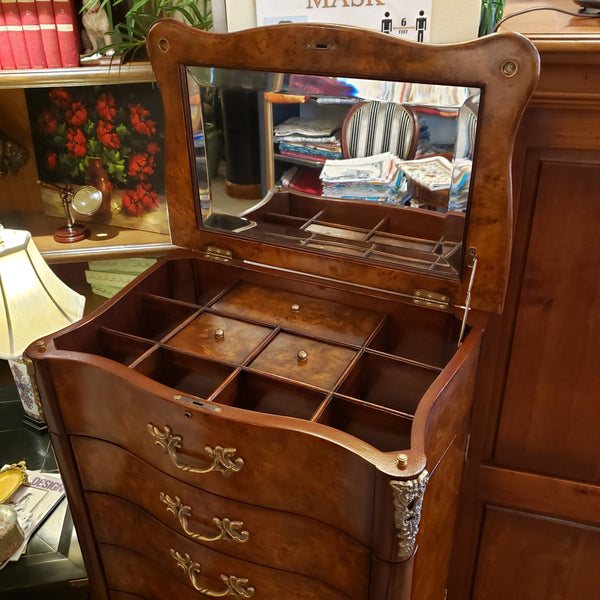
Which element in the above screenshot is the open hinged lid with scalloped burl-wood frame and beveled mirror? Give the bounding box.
[147,19,539,312]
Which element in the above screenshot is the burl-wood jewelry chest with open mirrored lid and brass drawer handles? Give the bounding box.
[28,20,538,600]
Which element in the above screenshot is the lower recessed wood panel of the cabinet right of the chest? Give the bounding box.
[472,507,600,600]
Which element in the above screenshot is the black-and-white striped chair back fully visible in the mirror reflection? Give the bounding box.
[342,100,419,160]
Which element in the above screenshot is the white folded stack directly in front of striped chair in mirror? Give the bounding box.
[320,152,402,202]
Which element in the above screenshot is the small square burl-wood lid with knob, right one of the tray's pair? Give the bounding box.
[250,333,356,390]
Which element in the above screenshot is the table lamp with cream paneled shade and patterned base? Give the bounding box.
[0,225,85,429]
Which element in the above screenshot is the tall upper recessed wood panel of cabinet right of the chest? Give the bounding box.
[494,162,600,482]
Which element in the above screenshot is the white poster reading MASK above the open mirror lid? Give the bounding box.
[256,0,431,43]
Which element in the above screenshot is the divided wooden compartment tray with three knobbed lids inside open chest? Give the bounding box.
[50,259,458,451]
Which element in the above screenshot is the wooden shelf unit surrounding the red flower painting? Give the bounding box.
[0,63,172,262]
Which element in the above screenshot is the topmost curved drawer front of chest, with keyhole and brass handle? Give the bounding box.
[51,360,376,547]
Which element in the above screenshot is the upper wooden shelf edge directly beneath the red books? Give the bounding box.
[0,62,155,89]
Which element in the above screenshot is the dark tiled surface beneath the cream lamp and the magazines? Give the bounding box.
[0,360,88,600]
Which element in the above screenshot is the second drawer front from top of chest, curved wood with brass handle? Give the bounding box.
[72,436,370,600]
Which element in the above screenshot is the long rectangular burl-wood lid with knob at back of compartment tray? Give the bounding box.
[212,282,382,346]
